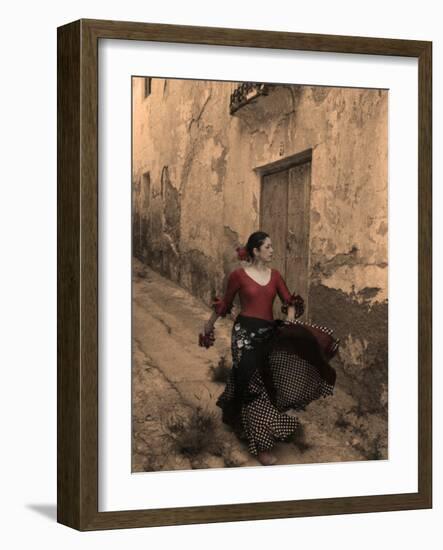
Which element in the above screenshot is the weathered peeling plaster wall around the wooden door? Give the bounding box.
[133,78,388,426]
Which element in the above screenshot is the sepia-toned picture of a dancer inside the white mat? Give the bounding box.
[128,75,389,473]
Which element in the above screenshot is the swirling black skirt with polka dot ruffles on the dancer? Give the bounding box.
[216,315,335,455]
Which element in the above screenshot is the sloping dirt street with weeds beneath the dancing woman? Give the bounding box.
[132,259,377,472]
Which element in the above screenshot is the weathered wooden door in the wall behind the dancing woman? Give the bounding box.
[260,162,311,318]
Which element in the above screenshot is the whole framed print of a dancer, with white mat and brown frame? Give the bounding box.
[58,20,432,530]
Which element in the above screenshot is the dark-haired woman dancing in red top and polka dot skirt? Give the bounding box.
[204,231,338,465]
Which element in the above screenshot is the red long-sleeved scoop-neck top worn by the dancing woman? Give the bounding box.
[212,267,295,321]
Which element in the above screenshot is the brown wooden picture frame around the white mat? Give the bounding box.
[57,19,432,531]
